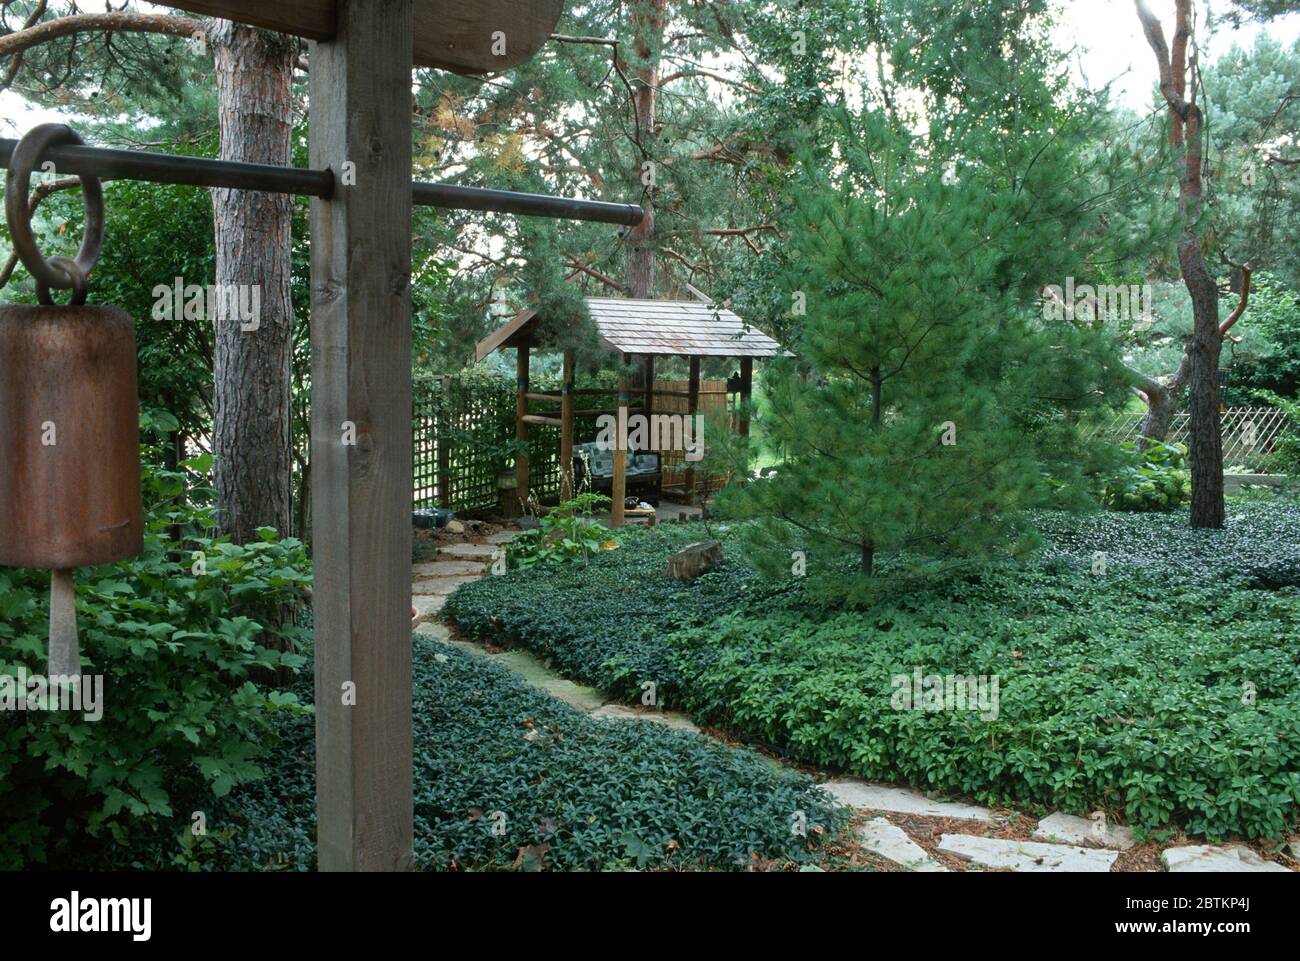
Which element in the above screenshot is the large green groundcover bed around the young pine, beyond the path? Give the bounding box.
[447,502,1300,837]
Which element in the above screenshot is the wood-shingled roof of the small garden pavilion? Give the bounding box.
[475,296,785,360]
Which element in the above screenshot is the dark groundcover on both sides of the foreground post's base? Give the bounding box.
[71,635,844,870]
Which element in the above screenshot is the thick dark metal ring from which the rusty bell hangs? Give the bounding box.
[4,124,104,303]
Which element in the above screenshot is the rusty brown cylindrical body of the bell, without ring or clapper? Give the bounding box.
[0,306,144,571]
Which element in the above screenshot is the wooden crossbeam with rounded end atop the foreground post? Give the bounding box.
[168,0,564,73]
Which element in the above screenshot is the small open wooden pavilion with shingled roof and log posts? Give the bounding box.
[475,296,784,527]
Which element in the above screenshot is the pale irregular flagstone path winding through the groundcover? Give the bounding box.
[411,531,1290,873]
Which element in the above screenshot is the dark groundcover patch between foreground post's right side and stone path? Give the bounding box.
[405,640,837,870]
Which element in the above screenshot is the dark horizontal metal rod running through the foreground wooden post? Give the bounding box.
[0,138,645,226]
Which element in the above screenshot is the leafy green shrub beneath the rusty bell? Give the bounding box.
[0,457,311,869]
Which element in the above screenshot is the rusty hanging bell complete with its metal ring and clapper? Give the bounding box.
[0,124,144,678]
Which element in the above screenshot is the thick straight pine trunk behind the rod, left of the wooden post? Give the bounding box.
[209,21,296,544]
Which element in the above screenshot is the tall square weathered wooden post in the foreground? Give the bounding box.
[311,0,415,871]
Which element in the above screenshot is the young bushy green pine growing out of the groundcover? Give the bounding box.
[719,103,1133,589]
